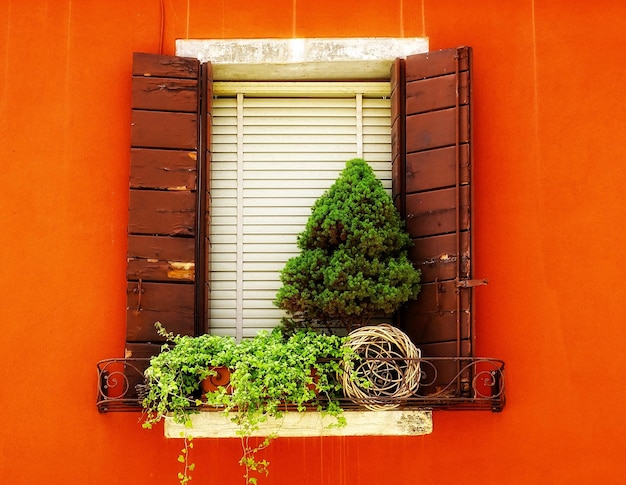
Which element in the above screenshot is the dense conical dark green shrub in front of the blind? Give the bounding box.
[274,159,420,331]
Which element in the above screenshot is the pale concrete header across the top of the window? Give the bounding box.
[176,37,428,81]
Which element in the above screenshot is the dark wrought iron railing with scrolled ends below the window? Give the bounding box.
[96,357,506,413]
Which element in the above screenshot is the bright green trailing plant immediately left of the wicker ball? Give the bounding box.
[206,329,353,484]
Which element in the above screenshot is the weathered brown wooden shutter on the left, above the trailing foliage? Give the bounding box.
[126,53,210,357]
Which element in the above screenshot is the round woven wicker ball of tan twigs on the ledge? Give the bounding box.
[342,323,421,411]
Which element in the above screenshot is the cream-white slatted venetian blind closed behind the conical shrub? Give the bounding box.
[210,83,391,338]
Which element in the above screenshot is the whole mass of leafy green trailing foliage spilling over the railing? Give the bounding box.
[143,325,356,484]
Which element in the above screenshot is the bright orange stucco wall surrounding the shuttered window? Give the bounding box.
[0,0,626,485]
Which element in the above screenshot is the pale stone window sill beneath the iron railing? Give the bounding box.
[164,410,433,438]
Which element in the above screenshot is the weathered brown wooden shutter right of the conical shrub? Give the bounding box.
[391,47,483,393]
